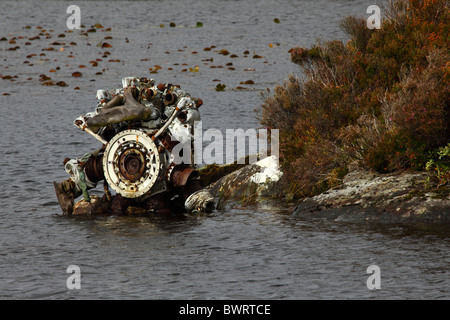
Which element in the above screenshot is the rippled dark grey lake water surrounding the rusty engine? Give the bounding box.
[0,0,450,299]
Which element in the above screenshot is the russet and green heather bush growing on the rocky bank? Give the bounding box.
[258,0,450,197]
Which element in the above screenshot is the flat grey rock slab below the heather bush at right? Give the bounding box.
[293,170,450,224]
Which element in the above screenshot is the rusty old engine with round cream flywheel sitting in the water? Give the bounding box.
[54,77,215,215]
